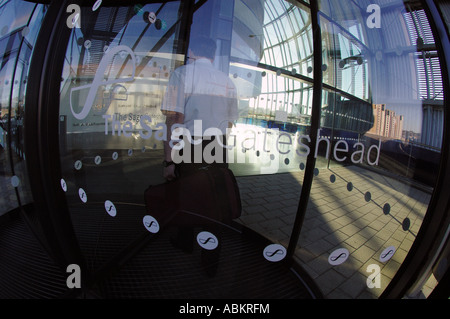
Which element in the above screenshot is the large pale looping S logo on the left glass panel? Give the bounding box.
[70,45,136,120]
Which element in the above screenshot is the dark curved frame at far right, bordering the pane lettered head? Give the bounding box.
[381,0,450,298]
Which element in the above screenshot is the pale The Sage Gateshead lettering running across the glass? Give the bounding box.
[103,115,381,166]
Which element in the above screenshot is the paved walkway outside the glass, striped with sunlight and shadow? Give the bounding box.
[234,166,431,298]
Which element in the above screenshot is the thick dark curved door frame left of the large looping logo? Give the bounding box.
[24,1,87,283]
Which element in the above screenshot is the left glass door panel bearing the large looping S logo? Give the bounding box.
[59,1,185,270]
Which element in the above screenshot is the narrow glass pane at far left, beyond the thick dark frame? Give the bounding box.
[0,1,46,215]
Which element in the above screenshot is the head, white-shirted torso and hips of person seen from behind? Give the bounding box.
[161,37,238,181]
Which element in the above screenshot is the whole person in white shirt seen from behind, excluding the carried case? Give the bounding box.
[161,37,238,276]
